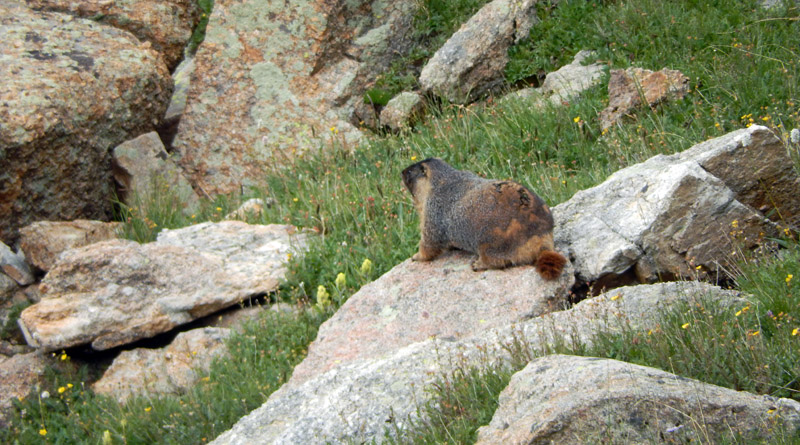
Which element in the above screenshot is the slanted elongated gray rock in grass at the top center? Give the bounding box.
[419,0,538,103]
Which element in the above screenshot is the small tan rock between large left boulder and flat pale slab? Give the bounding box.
[19,219,122,272]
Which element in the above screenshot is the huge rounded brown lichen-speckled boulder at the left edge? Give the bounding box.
[0,0,172,245]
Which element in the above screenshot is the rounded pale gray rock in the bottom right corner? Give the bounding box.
[477,355,800,444]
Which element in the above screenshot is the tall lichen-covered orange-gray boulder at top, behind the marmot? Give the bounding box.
[174,0,417,195]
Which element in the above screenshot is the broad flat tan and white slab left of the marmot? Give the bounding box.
[19,221,306,351]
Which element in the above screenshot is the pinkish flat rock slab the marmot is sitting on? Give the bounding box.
[290,252,574,384]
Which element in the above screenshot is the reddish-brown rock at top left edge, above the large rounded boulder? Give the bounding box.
[25,0,202,70]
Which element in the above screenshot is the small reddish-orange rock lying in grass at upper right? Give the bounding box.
[599,67,690,128]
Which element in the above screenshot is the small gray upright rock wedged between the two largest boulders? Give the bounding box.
[112,132,199,209]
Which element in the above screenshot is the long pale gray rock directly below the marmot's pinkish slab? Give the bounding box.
[213,280,741,445]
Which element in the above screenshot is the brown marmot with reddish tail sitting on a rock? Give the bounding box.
[403,158,567,280]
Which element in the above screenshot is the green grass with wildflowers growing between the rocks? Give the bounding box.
[6,0,800,443]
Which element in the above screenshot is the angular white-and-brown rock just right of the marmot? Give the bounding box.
[553,126,784,288]
